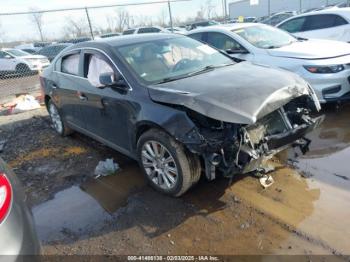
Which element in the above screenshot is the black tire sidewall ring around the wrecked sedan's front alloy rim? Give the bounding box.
[137,131,183,196]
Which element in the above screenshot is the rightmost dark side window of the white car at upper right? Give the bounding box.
[305,14,346,31]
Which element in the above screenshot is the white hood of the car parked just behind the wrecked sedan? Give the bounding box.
[267,39,350,59]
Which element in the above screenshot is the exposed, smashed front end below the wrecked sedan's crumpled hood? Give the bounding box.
[186,95,323,180]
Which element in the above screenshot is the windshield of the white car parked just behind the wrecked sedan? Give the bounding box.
[232,25,297,49]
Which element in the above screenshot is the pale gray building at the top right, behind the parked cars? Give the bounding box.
[229,0,342,19]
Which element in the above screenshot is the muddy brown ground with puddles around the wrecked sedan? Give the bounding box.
[0,105,350,257]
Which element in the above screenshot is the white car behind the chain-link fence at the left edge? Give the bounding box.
[0,48,50,75]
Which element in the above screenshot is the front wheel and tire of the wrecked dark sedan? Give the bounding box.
[137,129,200,197]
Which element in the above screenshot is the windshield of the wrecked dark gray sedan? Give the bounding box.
[117,37,233,84]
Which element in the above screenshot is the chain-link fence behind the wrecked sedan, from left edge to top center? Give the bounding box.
[0,0,223,111]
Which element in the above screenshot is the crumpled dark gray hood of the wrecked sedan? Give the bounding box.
[149,62,318,124]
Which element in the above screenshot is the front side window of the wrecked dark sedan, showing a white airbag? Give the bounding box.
[84,54,114,87]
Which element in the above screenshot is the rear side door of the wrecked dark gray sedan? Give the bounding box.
[52,50,85,128]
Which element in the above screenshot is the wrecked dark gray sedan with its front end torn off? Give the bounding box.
[41,34,321,196]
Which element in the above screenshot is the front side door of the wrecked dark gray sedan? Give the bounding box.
[81,49,133,153]
